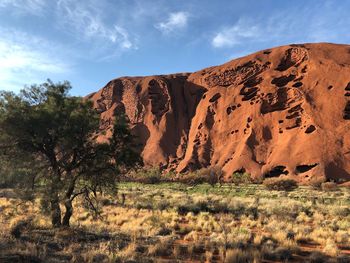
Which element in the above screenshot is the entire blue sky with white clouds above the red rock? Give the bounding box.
[0,0,350,95]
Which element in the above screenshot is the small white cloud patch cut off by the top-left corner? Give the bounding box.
[0,0,46,15]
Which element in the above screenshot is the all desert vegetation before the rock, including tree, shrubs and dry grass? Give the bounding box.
[0,81,350,262]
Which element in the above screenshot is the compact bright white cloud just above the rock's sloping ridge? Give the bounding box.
[212,19,260,48]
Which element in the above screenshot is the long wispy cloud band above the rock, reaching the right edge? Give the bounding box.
[210,1,350,48]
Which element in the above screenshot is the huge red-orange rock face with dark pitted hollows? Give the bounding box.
[88,43,350,183]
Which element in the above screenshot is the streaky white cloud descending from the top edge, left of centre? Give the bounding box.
[57,0,137,49]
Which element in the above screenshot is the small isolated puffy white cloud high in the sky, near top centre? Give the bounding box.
[155,12,189,34]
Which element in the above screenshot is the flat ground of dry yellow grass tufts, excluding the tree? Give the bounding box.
[0,182,350,262]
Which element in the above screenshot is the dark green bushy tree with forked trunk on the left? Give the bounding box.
[0,80,140,227]
